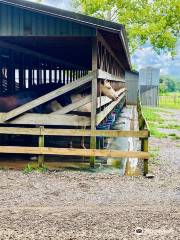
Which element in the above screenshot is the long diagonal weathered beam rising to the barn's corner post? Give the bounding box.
[4,72,96,121]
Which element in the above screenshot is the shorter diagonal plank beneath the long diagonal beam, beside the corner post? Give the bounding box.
[50,95,92,115]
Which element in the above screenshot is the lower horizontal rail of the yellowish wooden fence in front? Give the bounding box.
[0,146,149,159]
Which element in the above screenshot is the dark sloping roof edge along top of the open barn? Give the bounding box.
[0,0,131,68]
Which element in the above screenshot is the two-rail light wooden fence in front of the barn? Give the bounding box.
[0,127,149,174]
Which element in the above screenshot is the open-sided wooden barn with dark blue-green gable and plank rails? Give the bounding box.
[0,0,142,168]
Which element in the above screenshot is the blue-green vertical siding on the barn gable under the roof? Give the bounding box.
[0,3,96,36]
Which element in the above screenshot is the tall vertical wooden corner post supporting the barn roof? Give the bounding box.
[90,38,97,167]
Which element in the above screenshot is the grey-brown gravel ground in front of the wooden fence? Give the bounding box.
[0,109,180,240]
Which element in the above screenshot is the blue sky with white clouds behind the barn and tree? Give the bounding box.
[28,0,180,78]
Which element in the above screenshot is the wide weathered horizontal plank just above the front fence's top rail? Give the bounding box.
[0,113,90,127]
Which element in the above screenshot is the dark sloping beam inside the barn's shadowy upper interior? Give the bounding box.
[0,40,82,69]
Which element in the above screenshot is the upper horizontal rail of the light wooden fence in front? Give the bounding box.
[0,127,149,138]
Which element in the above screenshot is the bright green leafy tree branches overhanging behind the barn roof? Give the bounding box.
[74,0,180,56]
